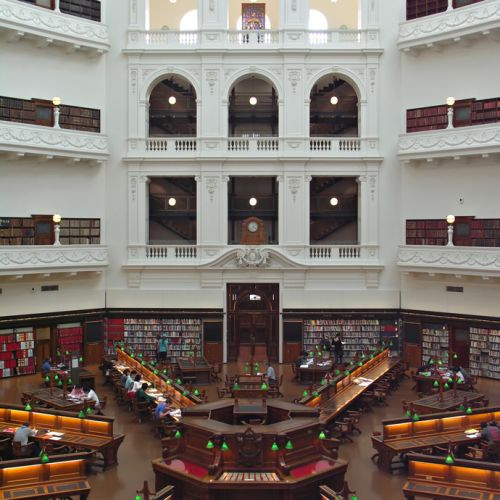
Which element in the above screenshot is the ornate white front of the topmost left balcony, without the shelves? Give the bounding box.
[0,0,109,54]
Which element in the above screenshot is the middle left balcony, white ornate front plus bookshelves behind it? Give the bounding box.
[0,97,109,163]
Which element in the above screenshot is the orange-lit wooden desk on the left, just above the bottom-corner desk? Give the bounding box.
[0,404,125,469]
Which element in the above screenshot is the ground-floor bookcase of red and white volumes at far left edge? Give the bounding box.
[0,326,35,378]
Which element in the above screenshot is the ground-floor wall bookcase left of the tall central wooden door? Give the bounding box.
[123,318,203,363]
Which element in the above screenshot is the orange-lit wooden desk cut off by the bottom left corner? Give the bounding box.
[0,453,90,500]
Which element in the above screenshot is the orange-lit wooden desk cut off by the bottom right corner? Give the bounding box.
[403,454,500,500]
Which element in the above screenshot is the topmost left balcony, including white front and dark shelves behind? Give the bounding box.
[0,0,110,56]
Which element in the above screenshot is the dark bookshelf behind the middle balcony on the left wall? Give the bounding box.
[0,95,101,133]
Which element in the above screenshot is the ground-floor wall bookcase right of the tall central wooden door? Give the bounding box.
[303,318,385,359]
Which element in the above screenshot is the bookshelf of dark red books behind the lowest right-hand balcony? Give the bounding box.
[406,217,500,247]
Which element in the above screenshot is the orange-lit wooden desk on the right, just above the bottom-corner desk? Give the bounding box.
[372,406,500,472]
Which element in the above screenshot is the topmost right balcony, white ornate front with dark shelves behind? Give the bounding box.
[398,0,500,55]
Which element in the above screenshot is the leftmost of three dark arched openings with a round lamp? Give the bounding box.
[149,75,196,137]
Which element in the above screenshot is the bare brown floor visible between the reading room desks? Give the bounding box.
[0,363,500,500]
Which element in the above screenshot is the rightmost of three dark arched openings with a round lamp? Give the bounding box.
[309,74,358,137]
